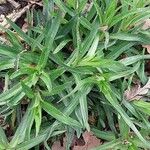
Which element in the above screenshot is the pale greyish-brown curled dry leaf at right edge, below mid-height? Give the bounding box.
[125,80,150,101]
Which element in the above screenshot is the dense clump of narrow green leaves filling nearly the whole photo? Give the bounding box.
[0,0,150,150]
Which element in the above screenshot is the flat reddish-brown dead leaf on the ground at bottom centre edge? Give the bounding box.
[73,131,101,150]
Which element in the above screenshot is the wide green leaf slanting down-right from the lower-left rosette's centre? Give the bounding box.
[42,101,82,128]
